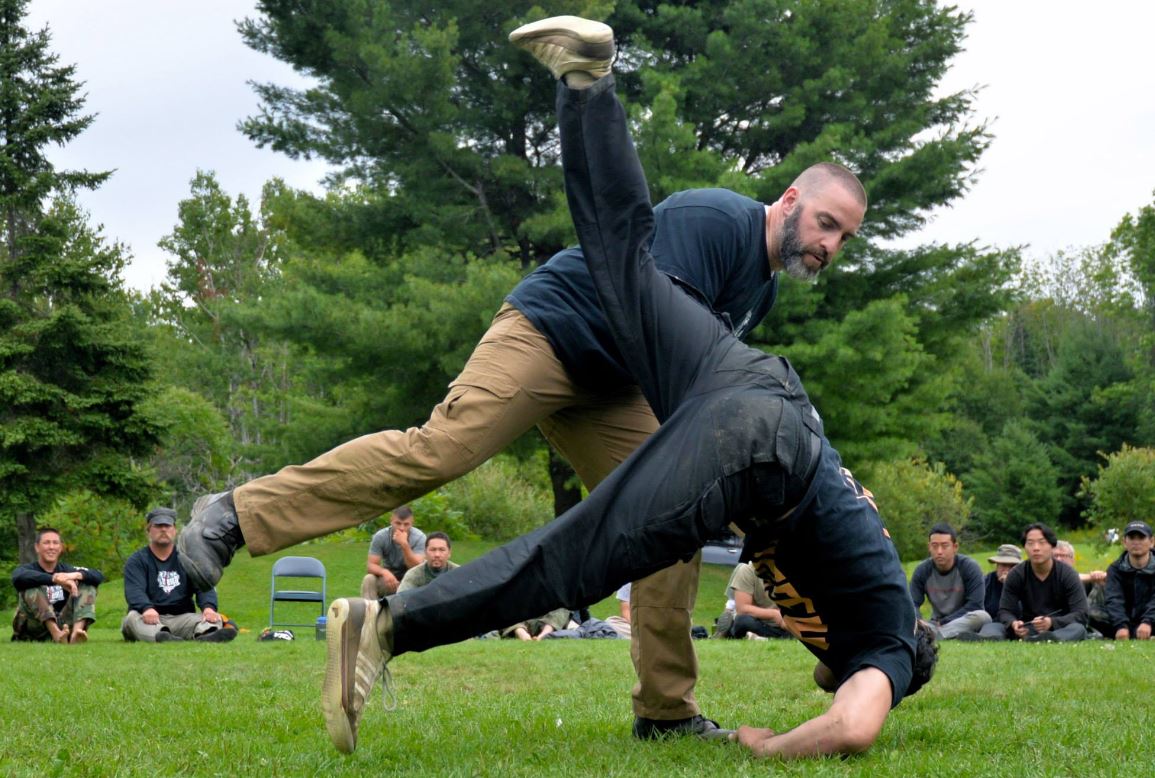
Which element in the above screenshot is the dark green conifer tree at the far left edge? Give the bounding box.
[0,0,155,560]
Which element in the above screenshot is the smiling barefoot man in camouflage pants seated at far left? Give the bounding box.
[12,526,104,643]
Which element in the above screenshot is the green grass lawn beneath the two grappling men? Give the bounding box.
[0,535,1155,776]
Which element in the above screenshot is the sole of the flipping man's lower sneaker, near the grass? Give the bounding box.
[321,599,365,754]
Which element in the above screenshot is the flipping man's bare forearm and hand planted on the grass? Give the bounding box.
[737,667,893,760]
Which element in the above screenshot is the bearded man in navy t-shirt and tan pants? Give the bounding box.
[178,12,865,739]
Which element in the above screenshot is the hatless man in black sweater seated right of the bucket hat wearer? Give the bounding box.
[999,523,1087,641]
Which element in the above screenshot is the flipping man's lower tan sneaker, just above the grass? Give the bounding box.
[321,598,393,754]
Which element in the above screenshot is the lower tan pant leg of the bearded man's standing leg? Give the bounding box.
[629,554,701,720]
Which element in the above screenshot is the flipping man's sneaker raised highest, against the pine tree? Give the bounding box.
[509,16,614,78]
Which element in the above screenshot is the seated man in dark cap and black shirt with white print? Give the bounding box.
[120,508,237,643]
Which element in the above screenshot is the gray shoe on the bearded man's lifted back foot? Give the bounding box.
[177,491,245,592]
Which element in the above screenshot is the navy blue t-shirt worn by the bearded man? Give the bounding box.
[506,184,777,390]
